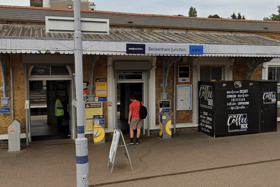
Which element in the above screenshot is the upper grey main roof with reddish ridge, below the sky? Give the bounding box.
[0,6,280,33]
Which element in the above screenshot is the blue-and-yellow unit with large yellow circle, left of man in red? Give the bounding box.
[93,115,105,144]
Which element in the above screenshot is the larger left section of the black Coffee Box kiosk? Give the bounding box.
[199,81,259,137]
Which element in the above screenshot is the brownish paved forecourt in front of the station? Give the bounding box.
[0,124,280,187]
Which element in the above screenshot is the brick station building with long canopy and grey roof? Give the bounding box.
[0,6,280,143]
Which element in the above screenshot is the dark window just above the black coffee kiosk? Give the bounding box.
[200,67,222,81]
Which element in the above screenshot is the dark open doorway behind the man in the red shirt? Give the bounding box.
[117,83,144,134]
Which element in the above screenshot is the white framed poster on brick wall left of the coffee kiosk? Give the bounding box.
[177,85,192,110]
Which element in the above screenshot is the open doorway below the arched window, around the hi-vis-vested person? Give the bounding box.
[29,80,71,141]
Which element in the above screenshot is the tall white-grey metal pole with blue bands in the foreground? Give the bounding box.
[74,0,89,187]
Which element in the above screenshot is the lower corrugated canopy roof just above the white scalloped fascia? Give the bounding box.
[0,24,280,46]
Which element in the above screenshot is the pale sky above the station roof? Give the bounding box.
[0,0,280,20]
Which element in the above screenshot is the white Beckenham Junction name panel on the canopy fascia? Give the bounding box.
[145,44,189,55]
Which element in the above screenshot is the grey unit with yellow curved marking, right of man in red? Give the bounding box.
[159,112,172,139]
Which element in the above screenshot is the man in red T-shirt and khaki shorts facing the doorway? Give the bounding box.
[128,95,143,145]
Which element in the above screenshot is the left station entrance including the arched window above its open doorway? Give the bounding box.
[27,65,74,142]
